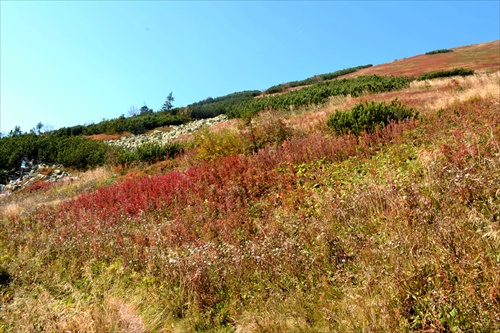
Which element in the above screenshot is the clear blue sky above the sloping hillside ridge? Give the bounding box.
[0,0,500,134]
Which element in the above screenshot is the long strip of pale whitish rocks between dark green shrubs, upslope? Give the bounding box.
[106,114,228,150]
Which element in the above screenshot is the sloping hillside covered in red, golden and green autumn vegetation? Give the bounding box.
[0,41,500,333]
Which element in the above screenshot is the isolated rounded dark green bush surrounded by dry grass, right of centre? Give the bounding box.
[327,99,418,136]
